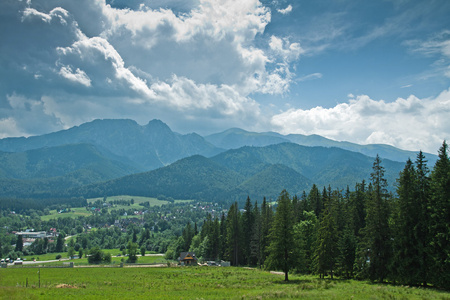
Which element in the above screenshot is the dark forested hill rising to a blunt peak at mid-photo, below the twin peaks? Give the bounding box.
[78,155,242,201]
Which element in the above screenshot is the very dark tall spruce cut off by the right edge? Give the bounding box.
[429,141,450,288]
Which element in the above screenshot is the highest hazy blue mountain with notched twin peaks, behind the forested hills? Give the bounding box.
[0,120,222,171]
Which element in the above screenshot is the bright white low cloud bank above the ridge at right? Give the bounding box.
[271,90,450,153]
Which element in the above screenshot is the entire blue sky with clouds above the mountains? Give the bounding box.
[0,0,450,153]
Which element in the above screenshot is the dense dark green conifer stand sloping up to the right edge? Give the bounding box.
[166,141,450,289]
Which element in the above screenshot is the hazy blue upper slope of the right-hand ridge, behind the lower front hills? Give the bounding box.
[211,143,404,188]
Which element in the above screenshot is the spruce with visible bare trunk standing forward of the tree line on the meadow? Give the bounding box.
[267,190,298,281]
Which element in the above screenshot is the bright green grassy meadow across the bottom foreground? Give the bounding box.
[0,267,450,299]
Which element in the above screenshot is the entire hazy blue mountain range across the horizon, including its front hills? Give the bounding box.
[0,120,436,201]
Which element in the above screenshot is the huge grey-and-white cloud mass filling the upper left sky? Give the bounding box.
[0,0,302,135]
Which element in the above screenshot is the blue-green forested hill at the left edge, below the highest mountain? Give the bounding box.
[0,144,137,198]
